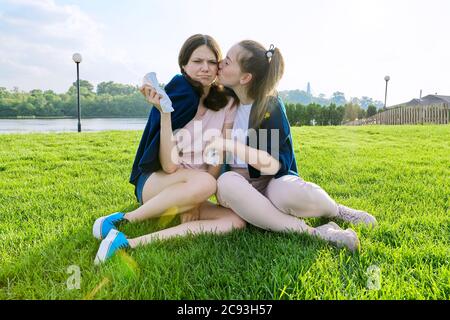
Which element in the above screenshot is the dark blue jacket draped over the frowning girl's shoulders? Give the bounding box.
[130,75,200,186]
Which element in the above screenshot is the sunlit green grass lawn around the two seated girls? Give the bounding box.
[0,125,450,299]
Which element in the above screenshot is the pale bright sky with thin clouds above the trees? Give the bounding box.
[0,0,450,105]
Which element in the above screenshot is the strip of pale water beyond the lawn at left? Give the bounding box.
[0,118,147,134]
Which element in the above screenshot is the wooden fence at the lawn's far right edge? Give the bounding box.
[344,103,450,126]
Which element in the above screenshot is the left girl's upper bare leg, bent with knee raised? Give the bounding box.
[125,169,216,222]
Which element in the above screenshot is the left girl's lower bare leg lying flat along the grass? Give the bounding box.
[128,201,245,248]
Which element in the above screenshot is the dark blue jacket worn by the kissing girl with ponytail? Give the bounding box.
[247,97,298,178]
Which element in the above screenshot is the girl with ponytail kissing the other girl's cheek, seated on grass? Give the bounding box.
[205,40,376,251]
